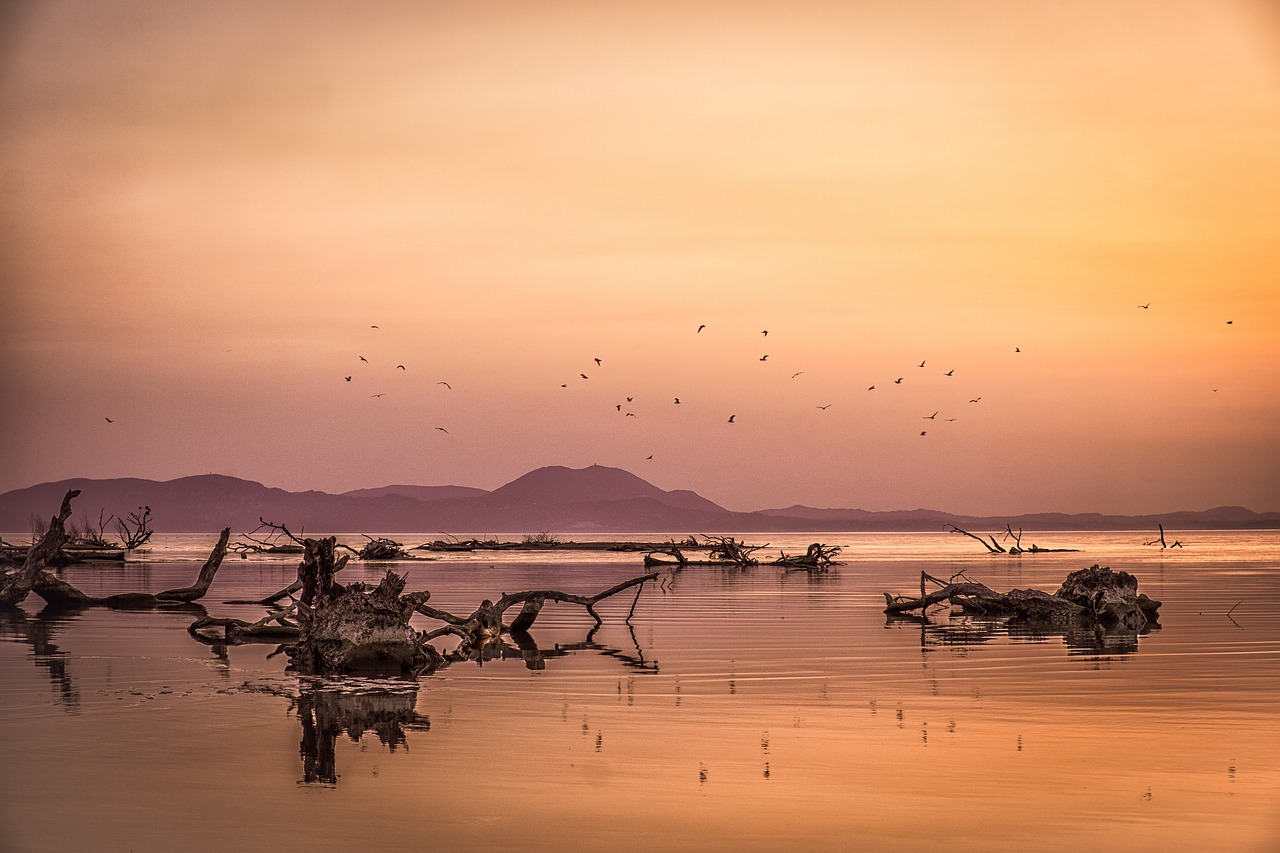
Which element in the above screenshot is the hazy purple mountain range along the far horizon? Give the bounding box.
[0,465,1280,537]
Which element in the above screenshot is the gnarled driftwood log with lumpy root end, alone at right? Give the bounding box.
[884,565,1160,628]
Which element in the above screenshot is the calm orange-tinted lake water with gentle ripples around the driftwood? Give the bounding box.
[0,532,1280,853]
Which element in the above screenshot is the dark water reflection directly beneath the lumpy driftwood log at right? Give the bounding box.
[884,613,1160,656]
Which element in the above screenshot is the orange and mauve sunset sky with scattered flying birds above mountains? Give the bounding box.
[0,0,1280,515]
